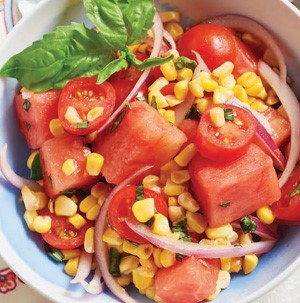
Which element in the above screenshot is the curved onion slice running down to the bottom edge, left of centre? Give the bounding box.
[95,166,152,303]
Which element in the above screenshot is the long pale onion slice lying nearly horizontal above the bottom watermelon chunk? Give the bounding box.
[126,219,276,259]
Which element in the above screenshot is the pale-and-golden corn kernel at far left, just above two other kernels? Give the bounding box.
[21,185,49,210]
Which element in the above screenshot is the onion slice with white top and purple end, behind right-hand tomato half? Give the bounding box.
[226,97,286,171]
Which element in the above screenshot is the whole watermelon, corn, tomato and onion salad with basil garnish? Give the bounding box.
[0,0,300,303]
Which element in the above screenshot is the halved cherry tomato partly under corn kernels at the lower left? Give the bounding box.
[39,207,93,249]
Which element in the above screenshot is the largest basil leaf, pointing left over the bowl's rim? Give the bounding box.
[0,23,115,92]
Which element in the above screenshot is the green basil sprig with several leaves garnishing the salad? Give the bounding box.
[0,0,171,92]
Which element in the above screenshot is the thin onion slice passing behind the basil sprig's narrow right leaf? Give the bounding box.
[97,12,164,133]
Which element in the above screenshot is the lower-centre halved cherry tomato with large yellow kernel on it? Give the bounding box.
[108,185,168,243]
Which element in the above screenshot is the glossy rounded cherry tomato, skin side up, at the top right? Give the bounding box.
[178,24,257,76]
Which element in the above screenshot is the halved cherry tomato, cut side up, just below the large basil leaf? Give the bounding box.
[58,77,116,135]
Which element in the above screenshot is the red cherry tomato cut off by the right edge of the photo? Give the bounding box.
[271,165,300,222]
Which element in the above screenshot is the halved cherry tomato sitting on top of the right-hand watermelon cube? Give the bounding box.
[196,104,256,162]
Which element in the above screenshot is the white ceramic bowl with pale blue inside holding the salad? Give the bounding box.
[0,0,300,303]
